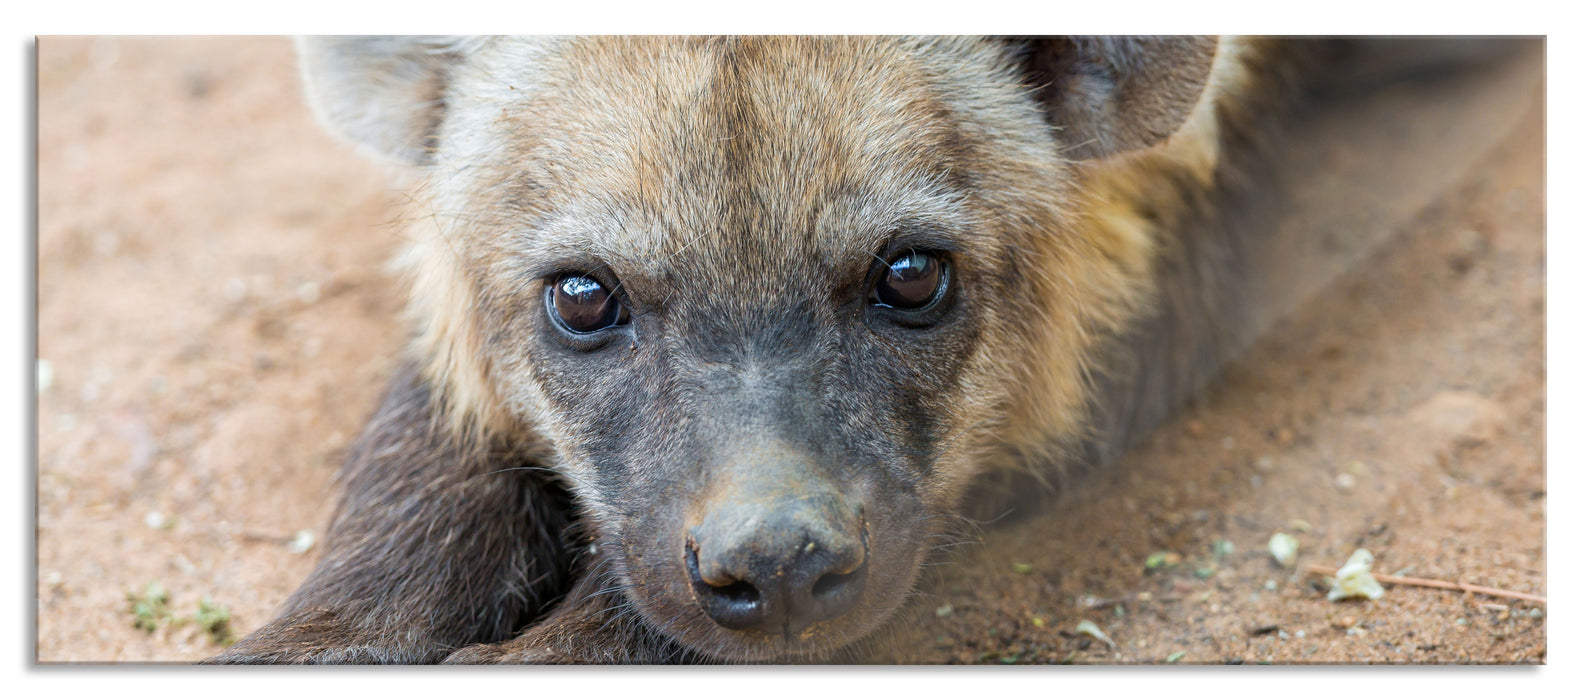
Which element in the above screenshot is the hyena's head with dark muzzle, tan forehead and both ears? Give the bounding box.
[302,38,1215,660]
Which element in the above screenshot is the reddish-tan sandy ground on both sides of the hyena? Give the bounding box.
[36,38,1547,664]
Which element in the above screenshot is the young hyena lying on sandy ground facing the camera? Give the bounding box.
[215,36,1518,664]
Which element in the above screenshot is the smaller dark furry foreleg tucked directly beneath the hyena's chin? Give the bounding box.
[445,576,702,664]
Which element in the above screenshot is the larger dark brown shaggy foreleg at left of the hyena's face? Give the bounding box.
[209,366,571,664]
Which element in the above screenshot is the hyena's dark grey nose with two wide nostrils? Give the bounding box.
[685,499,869,635]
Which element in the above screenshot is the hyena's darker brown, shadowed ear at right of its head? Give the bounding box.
[1011,36,1218,158]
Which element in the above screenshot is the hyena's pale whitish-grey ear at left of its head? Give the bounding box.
[297,36,479,165]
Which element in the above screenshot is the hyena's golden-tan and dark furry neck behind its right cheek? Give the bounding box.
[963,38,1311,519]
